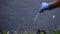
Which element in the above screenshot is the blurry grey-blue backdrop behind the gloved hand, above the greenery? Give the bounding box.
[0,0,60,34]
